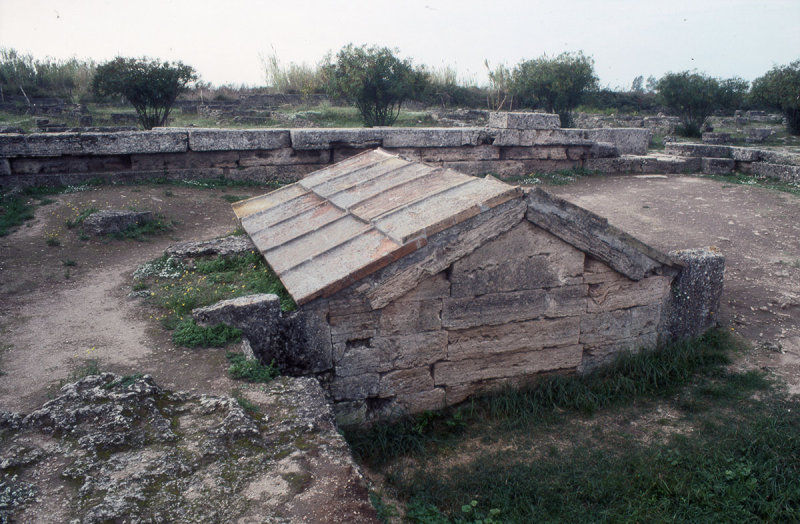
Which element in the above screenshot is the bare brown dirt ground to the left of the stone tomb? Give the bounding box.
[0,186,267,412]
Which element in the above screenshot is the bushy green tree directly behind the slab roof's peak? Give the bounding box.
[326,44,425,127]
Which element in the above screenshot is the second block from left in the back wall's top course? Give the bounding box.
[189,129,290,151]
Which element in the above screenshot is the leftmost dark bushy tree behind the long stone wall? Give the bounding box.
[92,57,197,129]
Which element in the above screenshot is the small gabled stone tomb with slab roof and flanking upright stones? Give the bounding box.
[195,149,724,424]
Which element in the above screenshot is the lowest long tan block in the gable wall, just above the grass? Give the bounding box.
[433,345,583,388]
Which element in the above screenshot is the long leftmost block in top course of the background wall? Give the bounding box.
[0,129,189,157]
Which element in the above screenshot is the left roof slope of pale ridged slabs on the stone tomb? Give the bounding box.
[233,149,521,304]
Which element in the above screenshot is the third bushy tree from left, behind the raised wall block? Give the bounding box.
[511,51,597,127]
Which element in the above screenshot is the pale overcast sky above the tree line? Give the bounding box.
[0,0,800,87]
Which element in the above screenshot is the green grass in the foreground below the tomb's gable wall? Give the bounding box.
[345,331,800,523]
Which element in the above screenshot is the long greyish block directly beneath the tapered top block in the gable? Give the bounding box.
[442,285,586,329]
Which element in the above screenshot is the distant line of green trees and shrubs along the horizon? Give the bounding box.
[0,44,800,136]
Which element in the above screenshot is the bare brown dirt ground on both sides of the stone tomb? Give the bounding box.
[0,175,800,412]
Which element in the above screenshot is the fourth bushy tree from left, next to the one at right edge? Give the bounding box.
[656,71,719,136]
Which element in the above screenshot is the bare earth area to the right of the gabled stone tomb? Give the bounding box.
[548,175,800,393]
